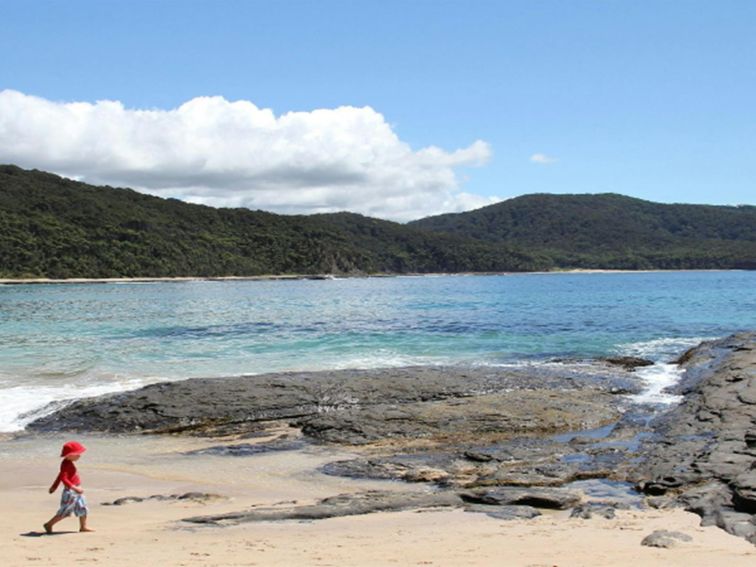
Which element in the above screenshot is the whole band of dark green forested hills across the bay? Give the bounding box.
[0,165,756,278]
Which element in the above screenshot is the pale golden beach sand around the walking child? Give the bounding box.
[0,436,756,567]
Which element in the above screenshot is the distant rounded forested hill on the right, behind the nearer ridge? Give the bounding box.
[410,194,756,269]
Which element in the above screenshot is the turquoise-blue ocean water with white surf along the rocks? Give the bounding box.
[0,271,756,431]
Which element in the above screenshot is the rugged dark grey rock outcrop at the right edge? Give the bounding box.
[631,333,756,544]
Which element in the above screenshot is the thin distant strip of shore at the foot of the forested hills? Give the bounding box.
[0,268,751,285]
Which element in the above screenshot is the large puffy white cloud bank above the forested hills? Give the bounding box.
[0,90,497,220]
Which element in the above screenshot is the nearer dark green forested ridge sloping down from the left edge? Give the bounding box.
[0,165,547,278]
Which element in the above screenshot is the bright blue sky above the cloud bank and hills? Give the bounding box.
[0,0,756,220]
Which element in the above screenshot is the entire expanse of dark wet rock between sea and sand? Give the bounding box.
[20,332,756,543]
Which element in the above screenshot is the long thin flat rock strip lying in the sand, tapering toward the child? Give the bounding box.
[183,491,462,525]
